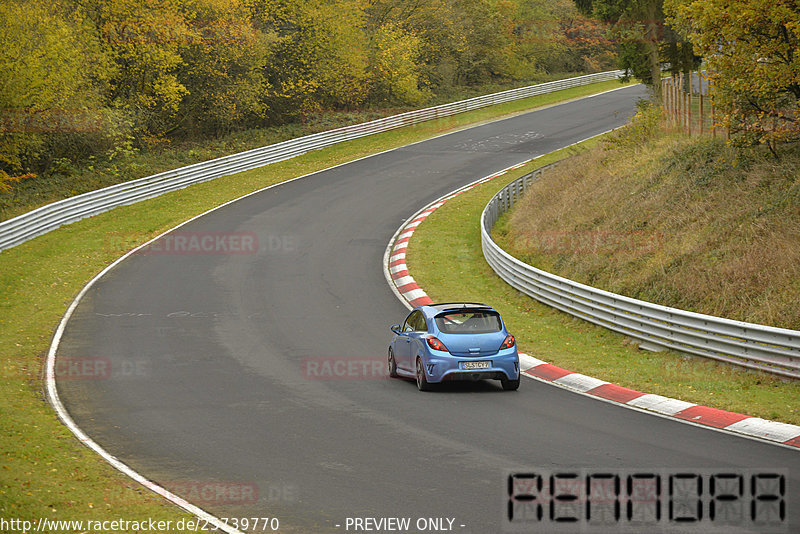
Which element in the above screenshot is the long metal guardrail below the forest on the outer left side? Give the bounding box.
[0,70,623,251]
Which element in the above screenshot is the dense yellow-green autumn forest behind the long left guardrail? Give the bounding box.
[0,0,616,207]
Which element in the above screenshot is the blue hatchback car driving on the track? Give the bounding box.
[388,302,519,391]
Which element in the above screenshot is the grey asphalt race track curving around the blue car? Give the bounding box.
[58,86,800,534]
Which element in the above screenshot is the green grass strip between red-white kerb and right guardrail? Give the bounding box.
[406,140,800,424]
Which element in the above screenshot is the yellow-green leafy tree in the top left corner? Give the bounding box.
[0,0,114,183]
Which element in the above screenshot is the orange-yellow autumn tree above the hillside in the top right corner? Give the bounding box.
[665,0,800,151]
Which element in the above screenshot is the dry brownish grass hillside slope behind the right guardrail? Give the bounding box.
[495,112,800,329]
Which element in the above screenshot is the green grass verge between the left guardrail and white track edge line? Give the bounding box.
[0,78,619,532]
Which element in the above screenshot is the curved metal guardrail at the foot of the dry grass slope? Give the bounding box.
[481,165,800,378]
